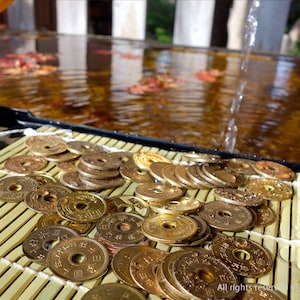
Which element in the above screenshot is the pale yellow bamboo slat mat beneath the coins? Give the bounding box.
[0,126,300,300]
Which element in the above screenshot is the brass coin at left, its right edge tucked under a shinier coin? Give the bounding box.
[24,183,72,214]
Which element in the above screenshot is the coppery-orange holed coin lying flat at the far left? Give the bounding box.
[4,155,48,174]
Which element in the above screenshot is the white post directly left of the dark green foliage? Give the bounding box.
[112,0,147,40]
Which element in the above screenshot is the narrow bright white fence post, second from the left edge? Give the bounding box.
[56,0,88,34]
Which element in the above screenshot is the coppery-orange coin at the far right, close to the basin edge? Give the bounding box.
[253,160,296,181]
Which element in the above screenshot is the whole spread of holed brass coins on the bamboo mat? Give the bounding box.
[0,136,295,300]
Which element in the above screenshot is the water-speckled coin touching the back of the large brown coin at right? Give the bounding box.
[214,188,264,206]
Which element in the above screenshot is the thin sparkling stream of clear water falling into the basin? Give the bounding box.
[224,0,260,152]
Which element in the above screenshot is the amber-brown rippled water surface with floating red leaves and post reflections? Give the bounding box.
[0,34,300,163]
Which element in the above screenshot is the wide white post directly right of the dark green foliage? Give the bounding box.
[173,0,215,47]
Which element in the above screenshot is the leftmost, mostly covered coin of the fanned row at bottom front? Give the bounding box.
[111,245,149,287]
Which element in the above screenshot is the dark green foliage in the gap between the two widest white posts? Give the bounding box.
[146,0,175,43]
